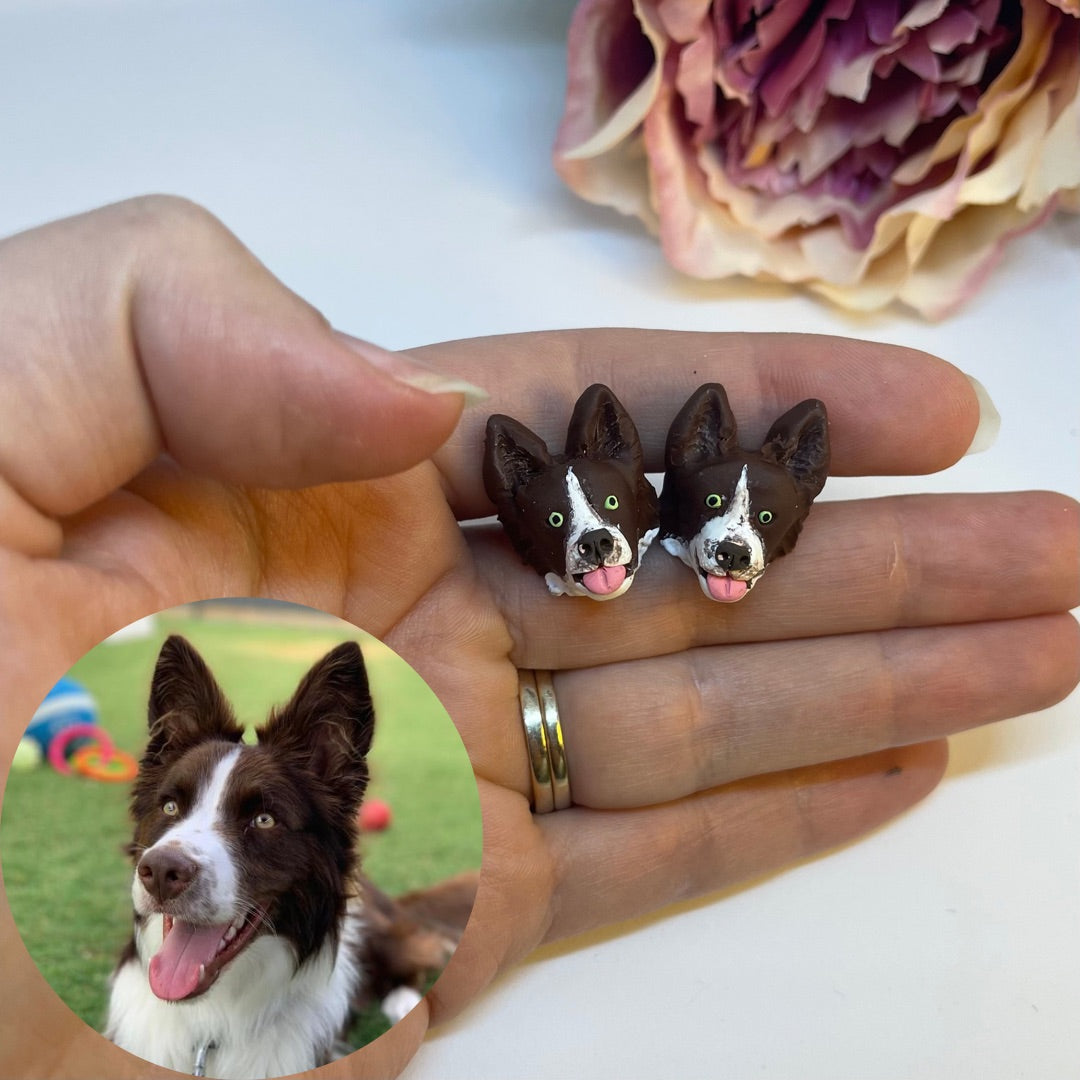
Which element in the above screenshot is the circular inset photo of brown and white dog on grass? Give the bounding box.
[0,599,482,1080]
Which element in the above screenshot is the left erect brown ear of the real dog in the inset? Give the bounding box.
[146,634,244,761]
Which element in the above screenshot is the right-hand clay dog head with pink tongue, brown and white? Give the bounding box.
[660,382,829,603]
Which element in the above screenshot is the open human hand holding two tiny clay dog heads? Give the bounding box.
[0,200,1080,1077]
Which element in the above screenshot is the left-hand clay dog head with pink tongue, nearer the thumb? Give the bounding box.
[484,383,659,600]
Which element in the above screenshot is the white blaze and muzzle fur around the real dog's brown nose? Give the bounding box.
[132,746,243,924]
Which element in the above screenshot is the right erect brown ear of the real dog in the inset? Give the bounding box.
[258,642,375,804]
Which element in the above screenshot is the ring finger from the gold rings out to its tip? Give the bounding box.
[555,615,1080,808]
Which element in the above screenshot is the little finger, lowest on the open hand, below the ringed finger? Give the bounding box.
[540,742,947,941]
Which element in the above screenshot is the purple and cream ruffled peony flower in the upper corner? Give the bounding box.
[555,0,1080,318]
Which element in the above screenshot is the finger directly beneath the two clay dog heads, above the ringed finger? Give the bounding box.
[469,492,1080,670]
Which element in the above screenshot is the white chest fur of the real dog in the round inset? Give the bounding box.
[106,914,363,1080]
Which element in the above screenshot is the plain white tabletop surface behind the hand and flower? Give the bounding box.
[0,0,1080,1080]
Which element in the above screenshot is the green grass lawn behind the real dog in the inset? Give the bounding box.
[0,605,482,1045]
